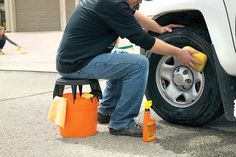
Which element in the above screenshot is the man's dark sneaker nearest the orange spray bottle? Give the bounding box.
[109,124,143,137]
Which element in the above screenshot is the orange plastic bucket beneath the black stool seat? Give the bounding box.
[60,93,98,137]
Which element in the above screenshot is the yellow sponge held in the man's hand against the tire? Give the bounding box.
[183,46,207,72]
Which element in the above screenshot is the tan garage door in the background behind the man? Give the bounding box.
[15,0,61,32]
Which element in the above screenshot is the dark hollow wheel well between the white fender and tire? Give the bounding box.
[149,10,212,43]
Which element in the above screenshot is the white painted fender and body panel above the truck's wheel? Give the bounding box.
[140,0,236,76]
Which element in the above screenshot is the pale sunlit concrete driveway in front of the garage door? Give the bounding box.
[0,32,139,72]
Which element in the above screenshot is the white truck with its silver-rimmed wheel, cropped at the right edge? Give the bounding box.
[140,0,236,126]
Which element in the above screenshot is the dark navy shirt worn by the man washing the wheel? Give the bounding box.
[56,0,155,73]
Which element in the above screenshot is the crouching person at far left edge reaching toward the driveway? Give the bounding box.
[0,26,21,55]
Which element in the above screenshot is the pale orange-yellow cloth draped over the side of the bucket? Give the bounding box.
[48,96,67,128]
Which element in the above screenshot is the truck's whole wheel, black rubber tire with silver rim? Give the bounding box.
[146,27,224,126]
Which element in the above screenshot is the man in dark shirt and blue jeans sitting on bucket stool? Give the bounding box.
[57,0,201,137]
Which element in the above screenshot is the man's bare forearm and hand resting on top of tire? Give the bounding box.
[134,10,184,34]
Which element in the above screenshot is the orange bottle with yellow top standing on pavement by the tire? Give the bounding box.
[143,100,156,142]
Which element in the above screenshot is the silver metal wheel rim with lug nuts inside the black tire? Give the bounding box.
[156,56,205,108]
